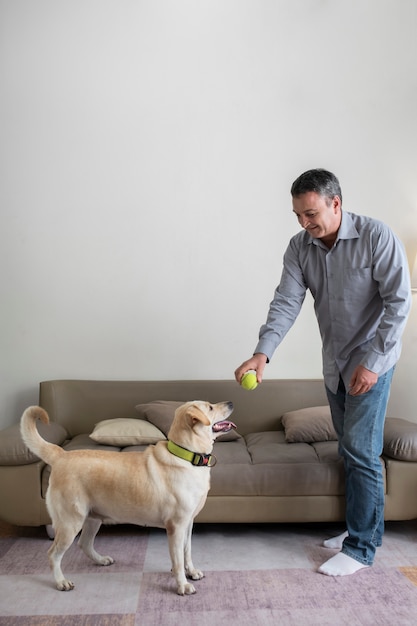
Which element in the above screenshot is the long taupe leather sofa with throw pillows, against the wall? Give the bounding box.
[0,379,417,526]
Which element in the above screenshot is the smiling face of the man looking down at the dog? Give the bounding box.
[292,191,342,245]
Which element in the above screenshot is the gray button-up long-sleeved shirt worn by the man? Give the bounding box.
[255,211,411,393]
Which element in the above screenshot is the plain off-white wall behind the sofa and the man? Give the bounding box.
[0,0,417,425]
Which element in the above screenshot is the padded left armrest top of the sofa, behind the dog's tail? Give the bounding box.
[0,422,68,465]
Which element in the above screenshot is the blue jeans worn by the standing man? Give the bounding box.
[326,367,394,565]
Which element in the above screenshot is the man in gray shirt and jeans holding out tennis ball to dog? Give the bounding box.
[235,169,411,576]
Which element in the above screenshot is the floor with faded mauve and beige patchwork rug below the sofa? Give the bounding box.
[0,522,417,626]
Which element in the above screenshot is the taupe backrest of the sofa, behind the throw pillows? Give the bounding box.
[39,379,327,437]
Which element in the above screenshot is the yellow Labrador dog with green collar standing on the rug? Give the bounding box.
[21,401,236,595]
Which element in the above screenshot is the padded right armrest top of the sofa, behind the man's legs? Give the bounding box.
[383,417,417,461]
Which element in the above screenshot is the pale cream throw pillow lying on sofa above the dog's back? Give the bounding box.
[90,417,165,448]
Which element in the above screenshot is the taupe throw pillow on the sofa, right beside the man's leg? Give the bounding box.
[281,405,337,443]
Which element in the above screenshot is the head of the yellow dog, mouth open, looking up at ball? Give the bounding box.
[168,400,236,454]
